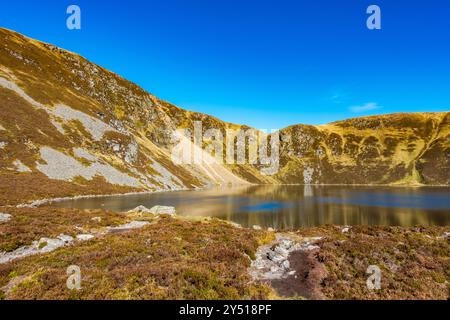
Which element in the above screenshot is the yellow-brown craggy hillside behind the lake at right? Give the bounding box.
[277,112,450,185]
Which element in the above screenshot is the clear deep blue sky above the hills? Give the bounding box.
[0,0,450,129]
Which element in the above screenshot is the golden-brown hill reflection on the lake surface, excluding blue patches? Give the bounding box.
[216,185,450,229]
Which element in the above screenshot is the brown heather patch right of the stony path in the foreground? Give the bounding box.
[298,226,450,299]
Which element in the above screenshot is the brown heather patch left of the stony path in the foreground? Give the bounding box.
[0,217,273,299]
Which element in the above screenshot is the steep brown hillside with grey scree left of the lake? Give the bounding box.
[0,29,270,203]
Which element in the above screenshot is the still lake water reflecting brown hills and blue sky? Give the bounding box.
[52,185,450,229]
